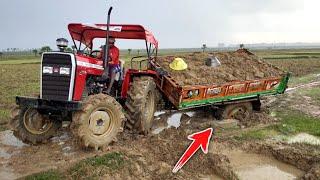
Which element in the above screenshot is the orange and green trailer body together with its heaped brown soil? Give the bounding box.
[152,51,290,109]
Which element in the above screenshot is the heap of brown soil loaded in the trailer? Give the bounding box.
[157,52,283,86]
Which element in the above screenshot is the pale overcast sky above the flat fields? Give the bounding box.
[0,0,320,49]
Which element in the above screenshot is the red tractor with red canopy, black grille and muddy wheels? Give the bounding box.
[11,9,158,149]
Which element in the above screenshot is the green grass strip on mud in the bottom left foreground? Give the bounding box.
[25,152,125,180]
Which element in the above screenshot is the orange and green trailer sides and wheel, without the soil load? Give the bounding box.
[151,59,290,118]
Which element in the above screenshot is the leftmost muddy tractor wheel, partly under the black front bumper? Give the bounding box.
[10,107,62,145]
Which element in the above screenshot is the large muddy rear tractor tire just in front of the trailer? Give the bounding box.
[124,76,158,135]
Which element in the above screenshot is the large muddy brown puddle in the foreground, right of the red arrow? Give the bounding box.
[226,151,304,180]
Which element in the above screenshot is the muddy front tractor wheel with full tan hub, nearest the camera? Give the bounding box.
[70,94,125,150]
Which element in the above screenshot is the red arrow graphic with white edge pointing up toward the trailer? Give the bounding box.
[172,128,213,173]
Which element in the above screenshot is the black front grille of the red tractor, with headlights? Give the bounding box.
[41,53,75,101]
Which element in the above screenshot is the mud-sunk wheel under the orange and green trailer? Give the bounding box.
[220,102,252,120]
